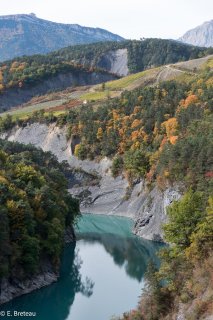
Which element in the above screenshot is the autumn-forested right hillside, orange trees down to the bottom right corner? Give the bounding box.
[1,62,213,320]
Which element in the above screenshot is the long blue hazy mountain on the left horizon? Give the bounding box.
[0,13,123,61]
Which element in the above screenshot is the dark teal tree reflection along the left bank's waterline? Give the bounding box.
[1,245,94,320]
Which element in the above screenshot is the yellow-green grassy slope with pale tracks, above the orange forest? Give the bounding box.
[1,56,213,119]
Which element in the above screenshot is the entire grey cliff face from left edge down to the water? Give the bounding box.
[2,123,180,241]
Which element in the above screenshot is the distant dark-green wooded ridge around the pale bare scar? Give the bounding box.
[50,38,211,73]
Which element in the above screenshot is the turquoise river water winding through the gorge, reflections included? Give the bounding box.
[1,214,162,320]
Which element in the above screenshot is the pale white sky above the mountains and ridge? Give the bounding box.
[0,0,213,39]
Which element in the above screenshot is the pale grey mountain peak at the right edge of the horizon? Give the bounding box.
[179,20,213,47]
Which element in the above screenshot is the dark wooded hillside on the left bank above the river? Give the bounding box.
[0,140,79,281]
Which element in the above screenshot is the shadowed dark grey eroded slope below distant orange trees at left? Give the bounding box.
[0,71,117,111]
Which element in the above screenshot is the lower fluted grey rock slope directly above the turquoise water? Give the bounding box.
[70,178,180,241]
